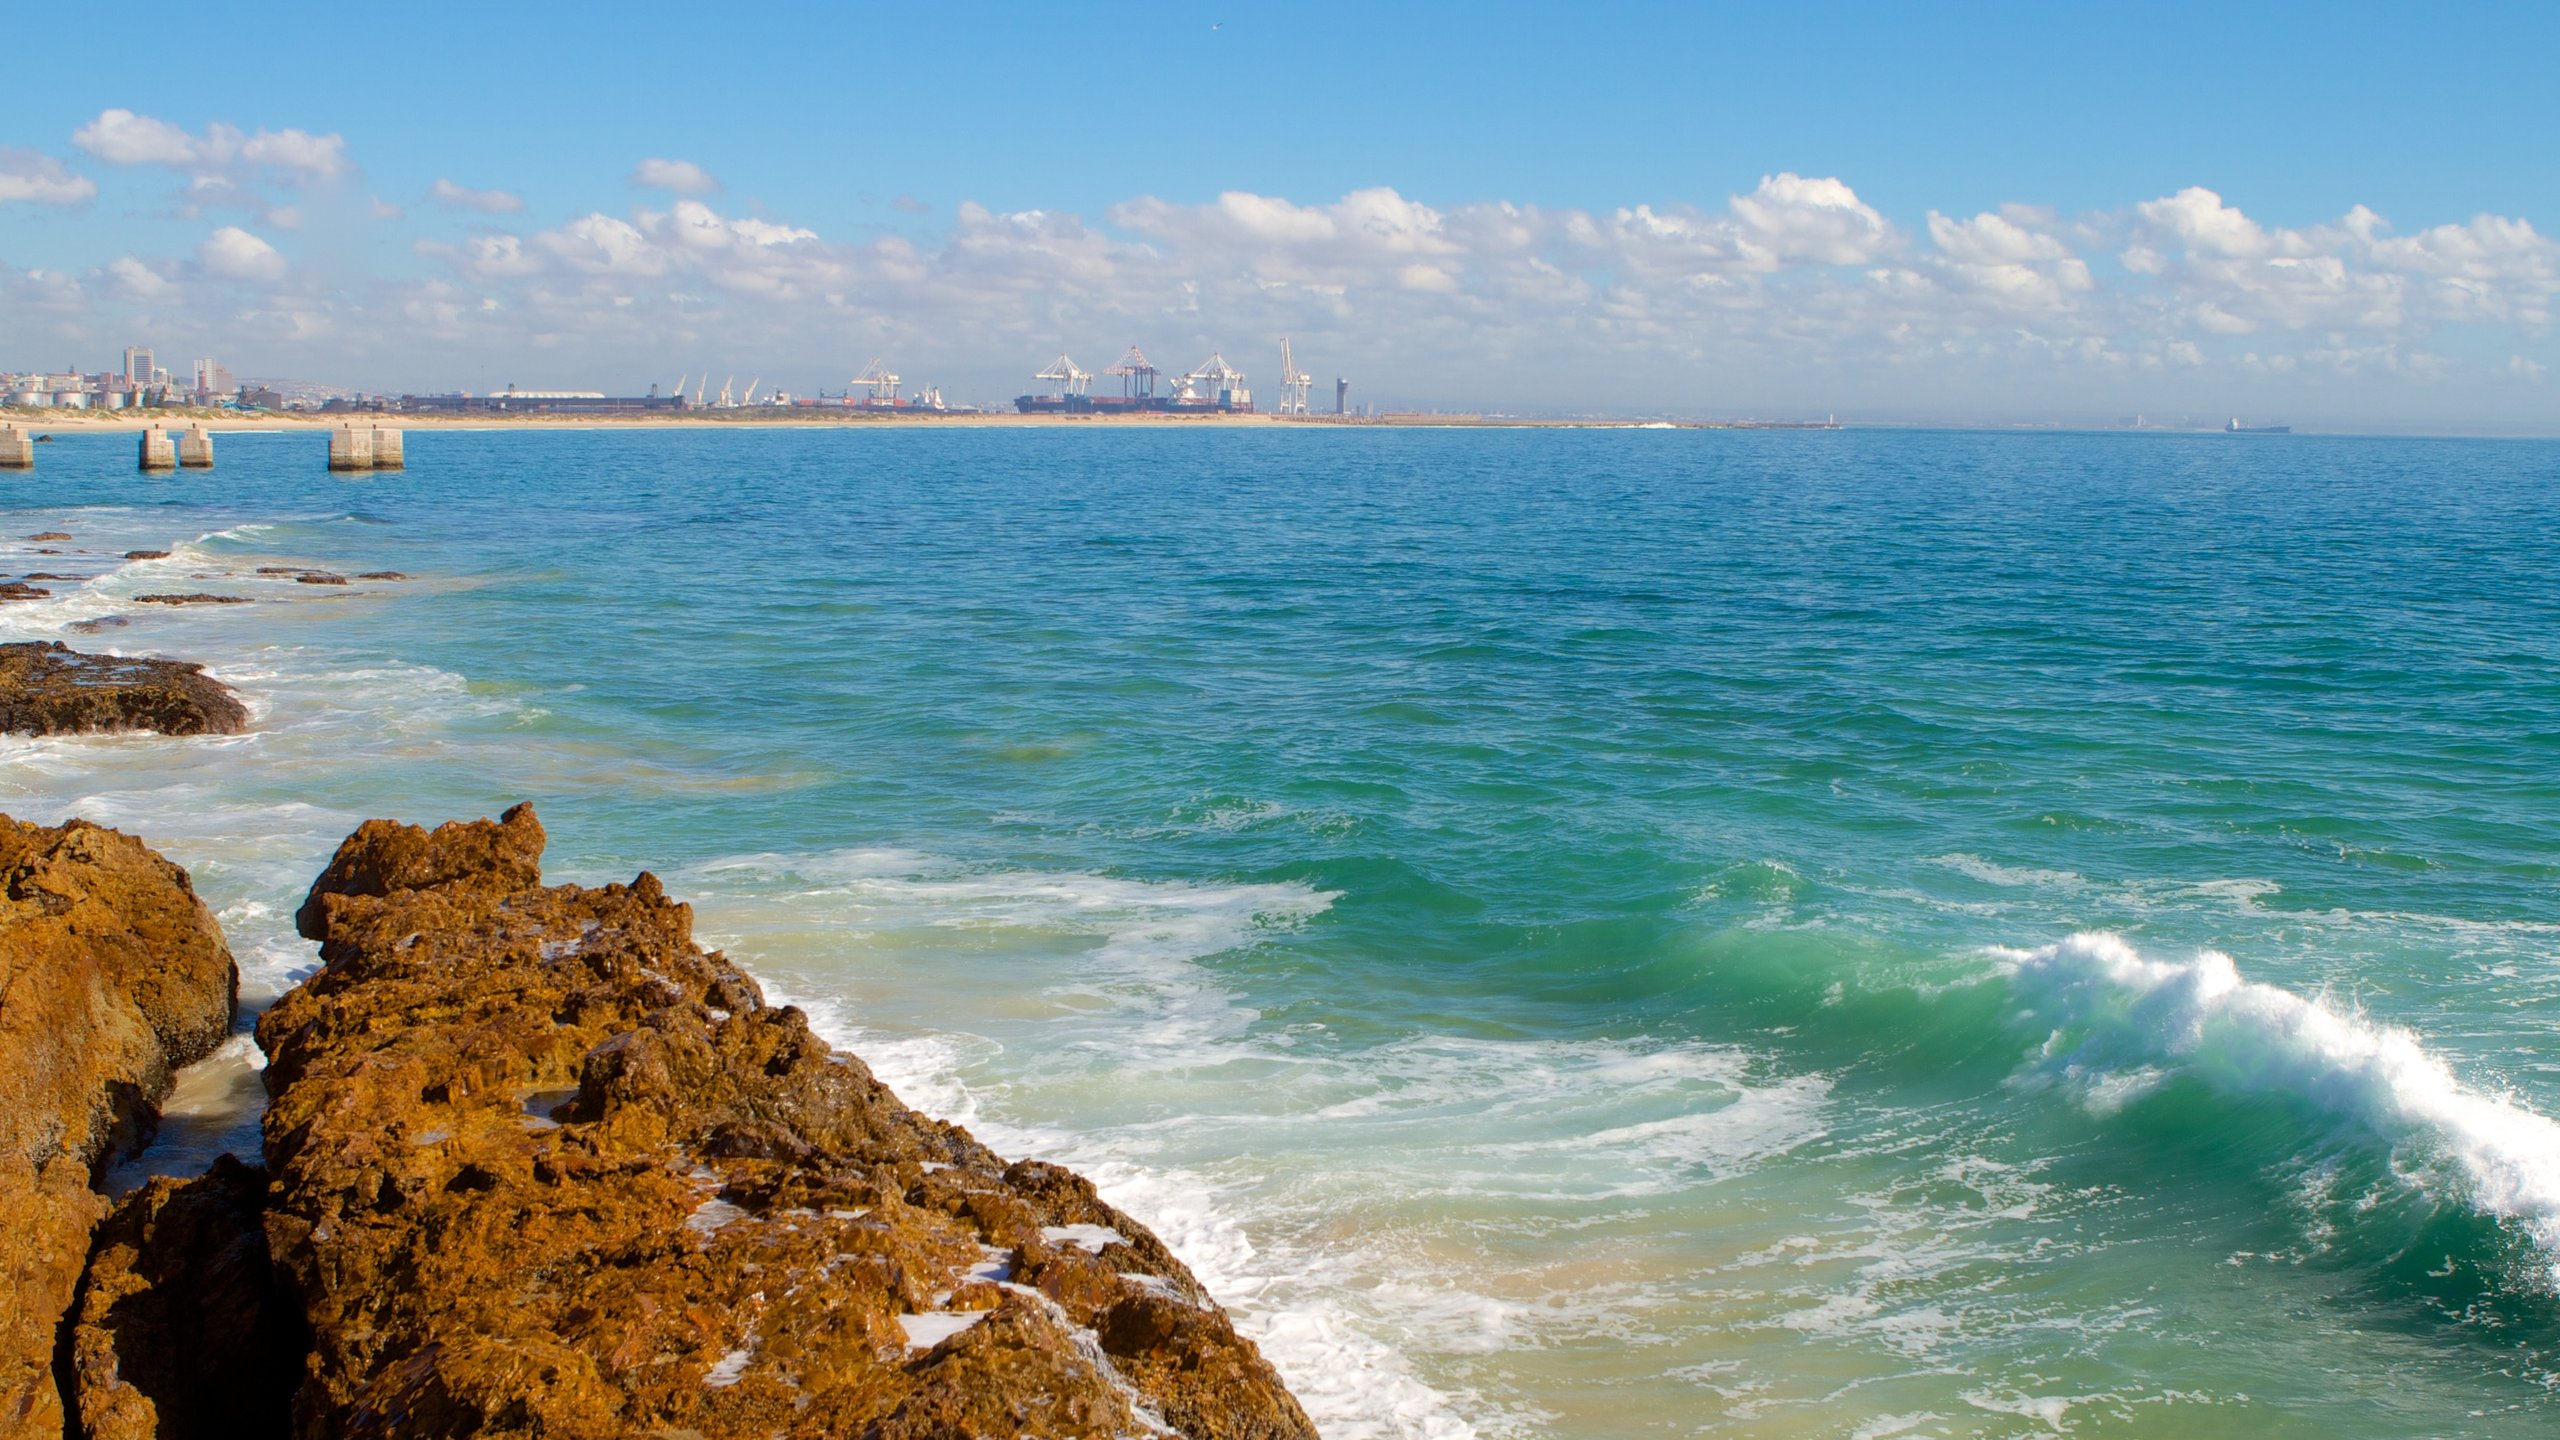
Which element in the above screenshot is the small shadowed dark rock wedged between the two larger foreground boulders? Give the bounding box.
[67,1156,305,1440]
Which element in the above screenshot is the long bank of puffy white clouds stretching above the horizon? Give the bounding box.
[40,165,2560,413]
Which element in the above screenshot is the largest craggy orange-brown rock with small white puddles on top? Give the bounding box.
[259,805,1313,1440]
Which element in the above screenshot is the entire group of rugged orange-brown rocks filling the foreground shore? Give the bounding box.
[0,805,1313,1440]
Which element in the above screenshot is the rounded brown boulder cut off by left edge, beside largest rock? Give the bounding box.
[0,815,238,1435]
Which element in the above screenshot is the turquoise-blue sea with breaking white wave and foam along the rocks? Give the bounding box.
[0,428,2560,1440]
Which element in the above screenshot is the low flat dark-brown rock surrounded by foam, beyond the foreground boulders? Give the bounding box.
[0,641,248,735]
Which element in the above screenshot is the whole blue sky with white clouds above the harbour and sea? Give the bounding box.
[0,3,2560,433]
